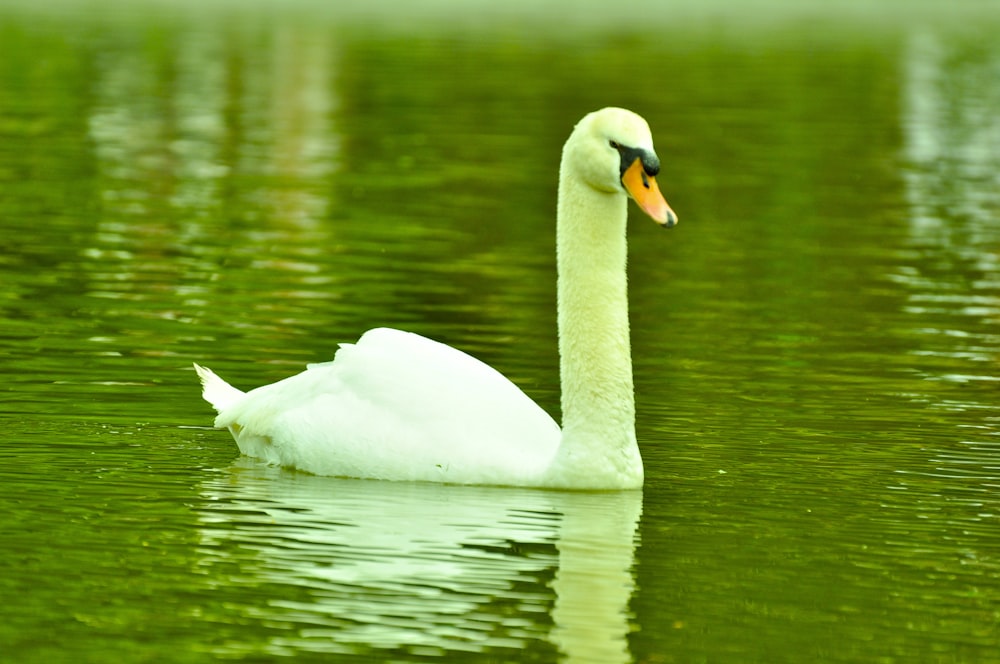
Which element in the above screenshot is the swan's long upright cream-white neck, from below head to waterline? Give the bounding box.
[552,164,643,488]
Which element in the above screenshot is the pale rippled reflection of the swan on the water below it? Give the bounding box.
[202,459,642,663]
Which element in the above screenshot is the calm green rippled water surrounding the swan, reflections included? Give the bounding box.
[0,2,1000,663]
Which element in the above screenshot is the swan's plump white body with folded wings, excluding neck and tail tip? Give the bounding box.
[216,328,560,484]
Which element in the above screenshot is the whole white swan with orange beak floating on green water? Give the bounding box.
[195,108,677,489]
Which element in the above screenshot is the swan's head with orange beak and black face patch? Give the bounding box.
[563,108,677,228]
